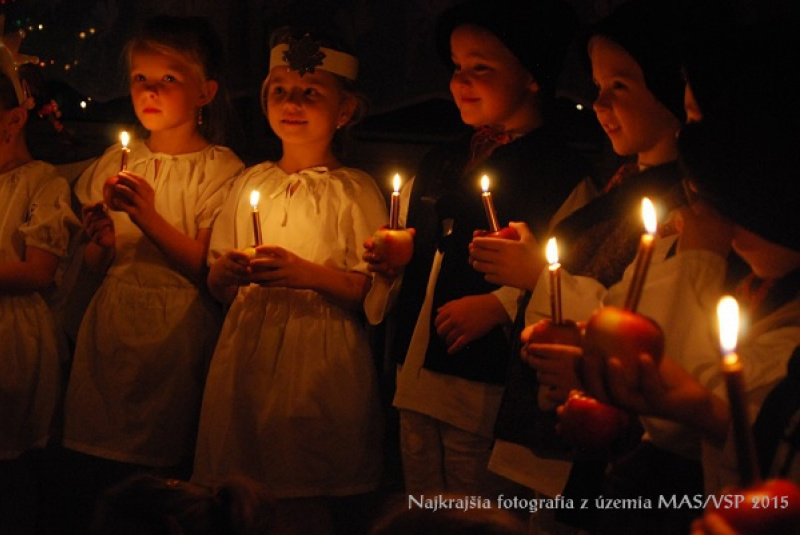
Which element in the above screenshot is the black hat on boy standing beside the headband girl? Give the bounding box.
[436,0,578,93]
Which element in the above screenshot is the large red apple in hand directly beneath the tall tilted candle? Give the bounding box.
[583,306,664,387]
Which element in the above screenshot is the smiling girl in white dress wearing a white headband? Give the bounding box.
[193,30,386,530]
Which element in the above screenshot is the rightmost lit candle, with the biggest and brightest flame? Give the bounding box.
[717,296,760,487]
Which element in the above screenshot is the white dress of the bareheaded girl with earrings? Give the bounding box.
[64,141,243,467]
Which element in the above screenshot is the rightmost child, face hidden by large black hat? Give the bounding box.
[609,24,800,493]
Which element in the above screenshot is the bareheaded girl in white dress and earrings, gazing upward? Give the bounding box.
[64,12,243,528]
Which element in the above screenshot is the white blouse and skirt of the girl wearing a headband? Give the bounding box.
[193,162,387,497]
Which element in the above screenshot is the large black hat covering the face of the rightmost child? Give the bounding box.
[678,25,800,251]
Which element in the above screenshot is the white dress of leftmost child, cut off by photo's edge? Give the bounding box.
[0,161,80,460]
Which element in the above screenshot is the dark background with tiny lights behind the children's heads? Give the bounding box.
[0,0,792,187]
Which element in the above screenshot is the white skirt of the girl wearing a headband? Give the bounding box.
[193,285,382,497]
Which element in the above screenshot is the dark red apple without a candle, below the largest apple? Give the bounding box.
[558,390,629,450]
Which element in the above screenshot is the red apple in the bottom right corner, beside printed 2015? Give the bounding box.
[708,479,800,535]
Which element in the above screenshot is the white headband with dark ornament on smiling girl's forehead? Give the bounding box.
[269,34,358,80]
